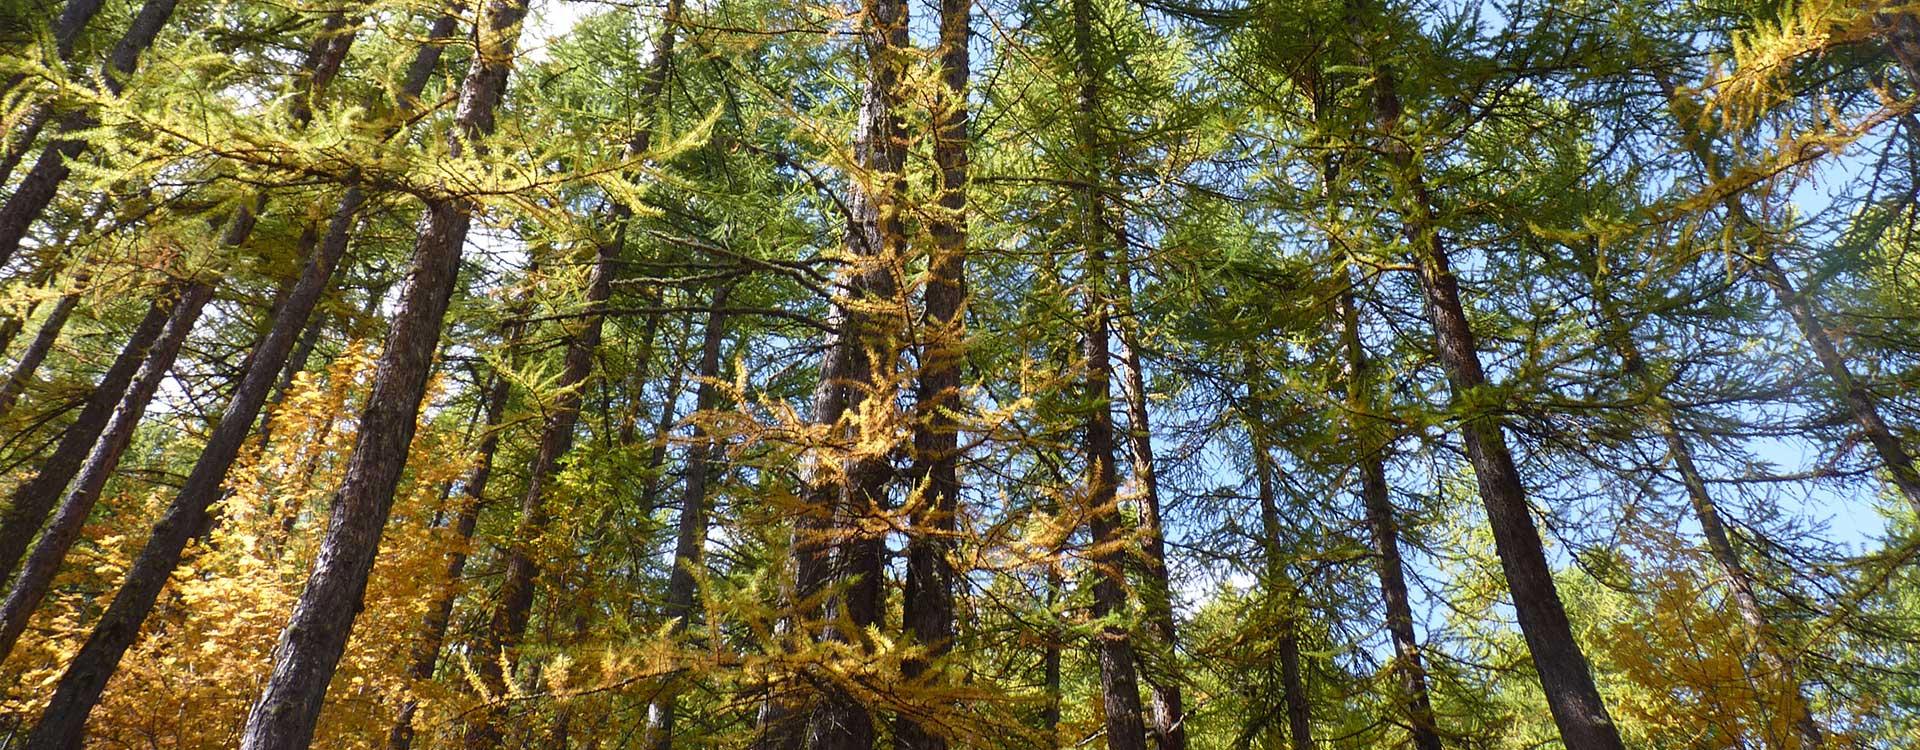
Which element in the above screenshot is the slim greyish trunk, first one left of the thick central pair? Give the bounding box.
[643,284,732,750]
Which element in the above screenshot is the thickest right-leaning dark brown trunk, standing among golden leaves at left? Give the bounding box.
[240,0,526,750]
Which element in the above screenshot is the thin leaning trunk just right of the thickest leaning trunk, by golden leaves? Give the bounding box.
[386,370,513,750]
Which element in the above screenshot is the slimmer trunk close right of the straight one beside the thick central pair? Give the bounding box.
[1116,236,1187,750]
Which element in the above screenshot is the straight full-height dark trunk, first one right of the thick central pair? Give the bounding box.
[1071,0,1146,750]
